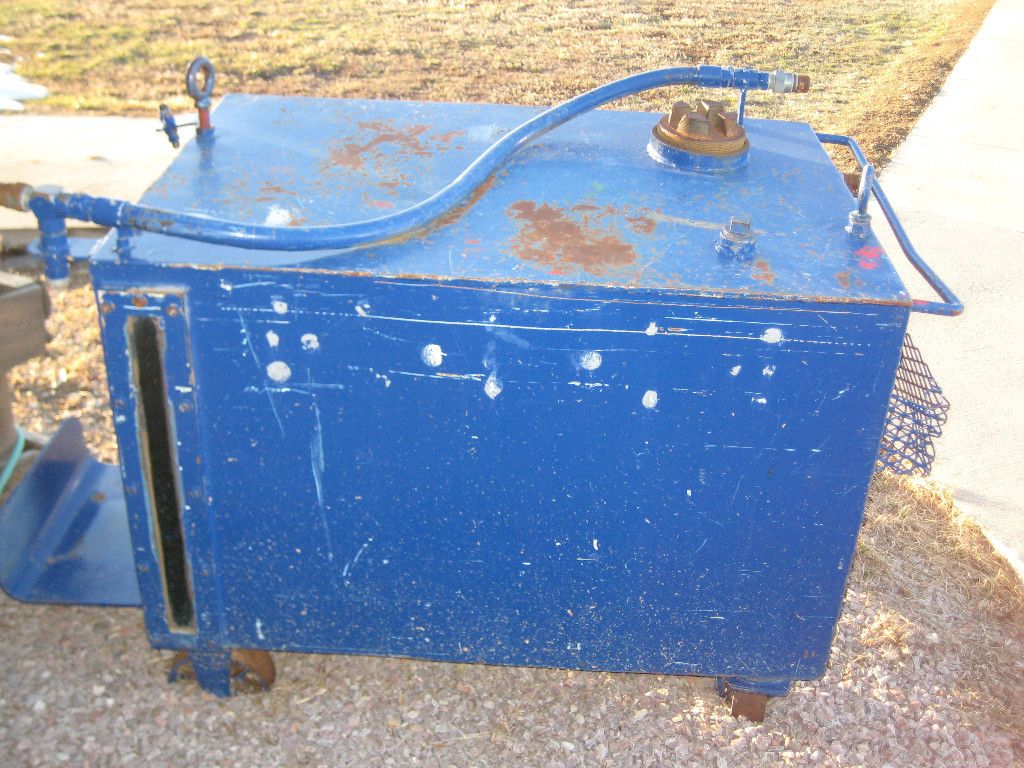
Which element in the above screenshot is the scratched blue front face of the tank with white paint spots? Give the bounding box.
[94,257,907,678]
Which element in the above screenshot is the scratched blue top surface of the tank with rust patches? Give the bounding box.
[94,95,910,305]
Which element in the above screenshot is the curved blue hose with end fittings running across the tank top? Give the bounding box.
[0,61,808,279]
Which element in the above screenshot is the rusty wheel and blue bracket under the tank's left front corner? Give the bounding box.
[167,648,278,696]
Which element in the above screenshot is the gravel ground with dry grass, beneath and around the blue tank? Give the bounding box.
[0,274,1024,768]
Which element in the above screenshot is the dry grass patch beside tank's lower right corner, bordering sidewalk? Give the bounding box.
[851,473,1024,733]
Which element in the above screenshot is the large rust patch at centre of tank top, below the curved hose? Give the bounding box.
[506,200,638,275]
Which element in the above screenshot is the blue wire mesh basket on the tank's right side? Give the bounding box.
[876,334,949,475]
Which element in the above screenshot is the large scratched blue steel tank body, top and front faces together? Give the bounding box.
[79,96,910,696]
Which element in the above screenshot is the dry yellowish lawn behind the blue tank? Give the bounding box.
[0,0,992,164]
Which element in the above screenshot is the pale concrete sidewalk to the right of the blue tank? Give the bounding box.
[874,0,1024,574]
